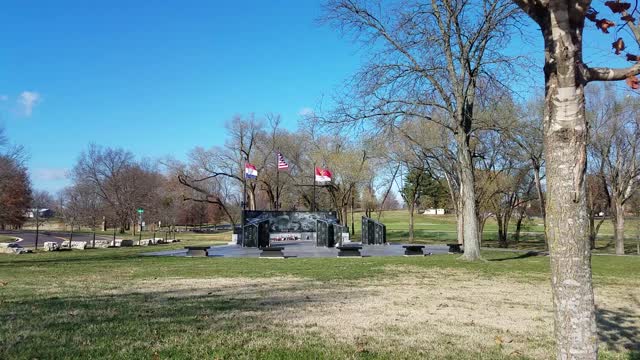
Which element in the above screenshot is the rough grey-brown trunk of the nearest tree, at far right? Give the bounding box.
[541,1,597,359]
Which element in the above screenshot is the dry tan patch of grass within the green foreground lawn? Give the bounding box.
[90,266,640,358]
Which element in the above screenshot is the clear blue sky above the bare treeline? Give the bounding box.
[0,0,632,192]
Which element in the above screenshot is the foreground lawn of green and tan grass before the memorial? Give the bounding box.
[0,245,640,359]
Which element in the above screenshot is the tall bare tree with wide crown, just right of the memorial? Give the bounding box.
[327,0,515,260]
